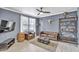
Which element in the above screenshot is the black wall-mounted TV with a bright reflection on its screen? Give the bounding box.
[0,20,15,33]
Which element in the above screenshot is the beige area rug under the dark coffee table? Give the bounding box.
[29,39,58,52]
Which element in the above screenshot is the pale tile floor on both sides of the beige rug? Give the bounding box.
[4,38,79,52]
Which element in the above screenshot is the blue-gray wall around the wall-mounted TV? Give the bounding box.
[0,9,20,42]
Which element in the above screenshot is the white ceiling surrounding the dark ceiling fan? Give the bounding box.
[7,7,77,17]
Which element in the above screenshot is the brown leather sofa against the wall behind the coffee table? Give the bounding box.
[40,32,59,40]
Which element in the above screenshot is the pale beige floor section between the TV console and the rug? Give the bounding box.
[5,41,47,52]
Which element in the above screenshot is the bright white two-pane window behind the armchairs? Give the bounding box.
[21,16,36,33]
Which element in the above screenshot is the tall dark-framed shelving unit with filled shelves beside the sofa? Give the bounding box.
[59,17,77,43]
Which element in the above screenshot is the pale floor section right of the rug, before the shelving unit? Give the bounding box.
[56,42,79,52]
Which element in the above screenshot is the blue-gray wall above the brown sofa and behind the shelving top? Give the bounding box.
[40,11,77,32]
